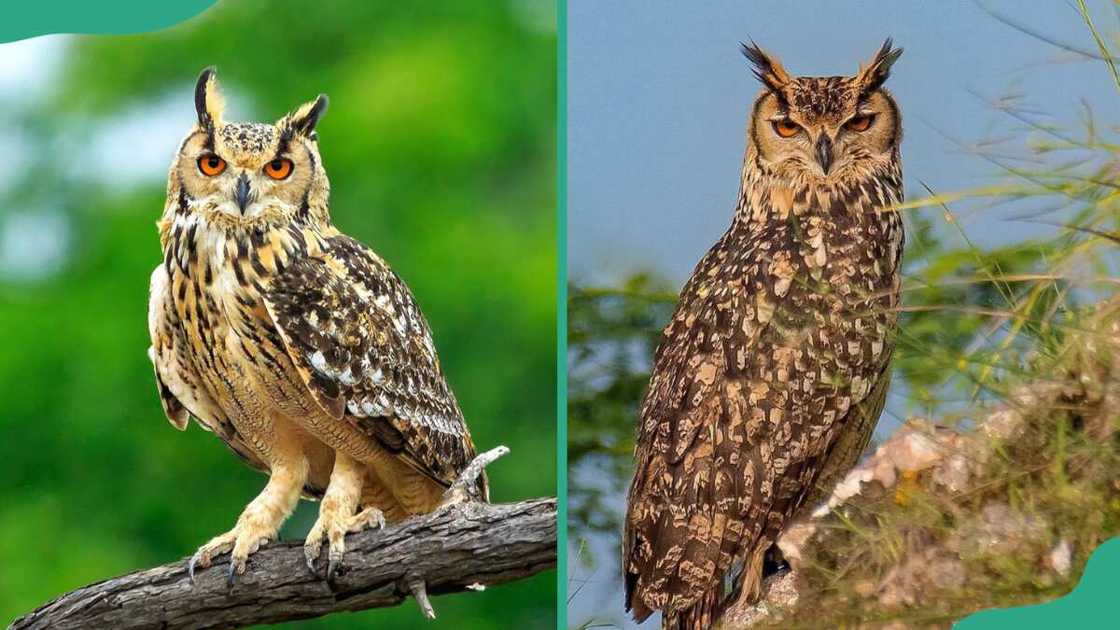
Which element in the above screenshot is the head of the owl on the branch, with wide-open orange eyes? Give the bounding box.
[167,68,330,226]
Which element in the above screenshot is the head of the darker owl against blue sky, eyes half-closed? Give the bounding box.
[743,39,903,182]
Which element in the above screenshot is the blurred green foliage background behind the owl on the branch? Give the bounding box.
[0,0,557,629]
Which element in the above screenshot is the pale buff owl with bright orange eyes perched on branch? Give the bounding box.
[149,70,487,584]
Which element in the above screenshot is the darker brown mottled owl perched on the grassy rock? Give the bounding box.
[623,39,903,629]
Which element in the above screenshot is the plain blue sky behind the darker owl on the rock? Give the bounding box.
[568,0,1120,628]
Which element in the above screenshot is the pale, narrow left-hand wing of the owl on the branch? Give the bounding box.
[148,265,268,471]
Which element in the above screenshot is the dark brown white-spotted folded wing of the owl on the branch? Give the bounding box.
[263,234,485,493]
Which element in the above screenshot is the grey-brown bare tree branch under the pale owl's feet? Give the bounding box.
[9,499,557,630]
